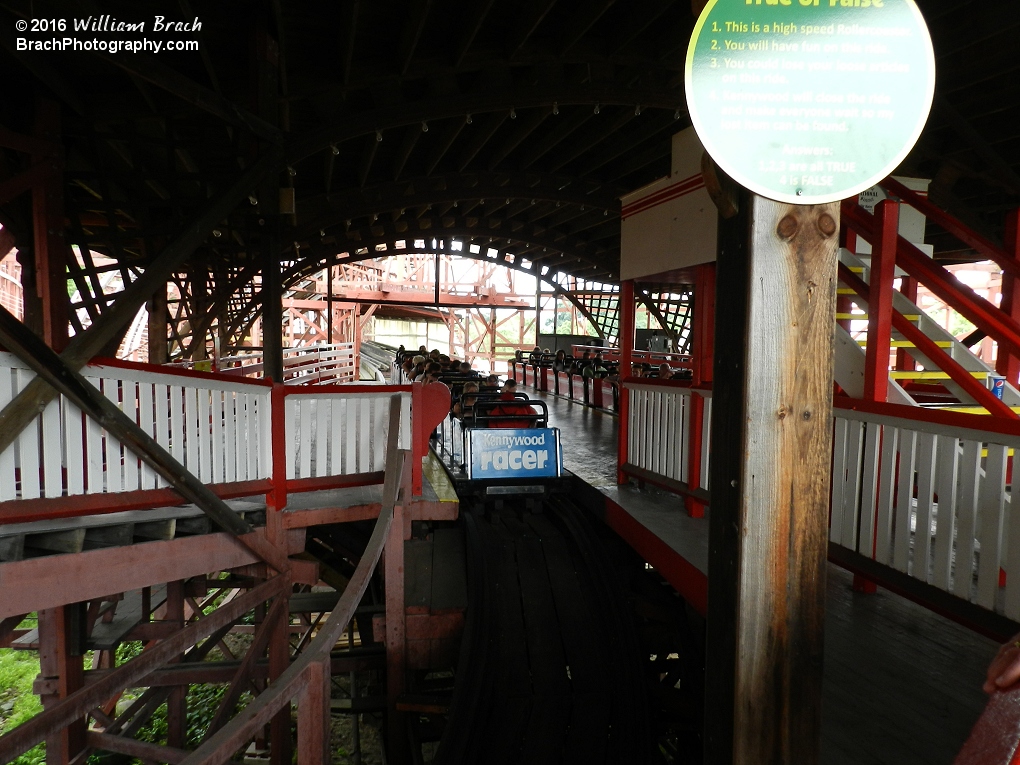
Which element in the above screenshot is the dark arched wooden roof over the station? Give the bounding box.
[0,0,1020,340]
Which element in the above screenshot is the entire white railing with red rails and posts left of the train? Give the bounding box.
[0,352,426,523]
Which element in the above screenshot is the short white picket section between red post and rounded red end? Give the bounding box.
[284,386,411,479]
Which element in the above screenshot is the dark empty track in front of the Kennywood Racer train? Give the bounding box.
[434,499,653,765]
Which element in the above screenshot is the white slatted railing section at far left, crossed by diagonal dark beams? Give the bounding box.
[0,353,272,501]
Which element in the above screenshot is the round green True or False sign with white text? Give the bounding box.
[686,0,935,204]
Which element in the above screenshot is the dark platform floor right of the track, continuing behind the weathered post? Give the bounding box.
[527,388,998,765]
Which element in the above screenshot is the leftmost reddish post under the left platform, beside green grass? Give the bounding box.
[39,603,86,765]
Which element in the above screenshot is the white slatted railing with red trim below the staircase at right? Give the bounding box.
[829,405,1020,619]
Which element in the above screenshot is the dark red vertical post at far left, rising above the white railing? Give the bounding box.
[32,99,67,353]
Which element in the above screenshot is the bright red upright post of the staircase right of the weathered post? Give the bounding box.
[864,199,900,401]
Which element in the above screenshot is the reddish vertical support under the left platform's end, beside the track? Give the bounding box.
[384,505,408,765]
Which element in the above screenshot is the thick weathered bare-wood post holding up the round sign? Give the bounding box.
[705,197,839,765]
